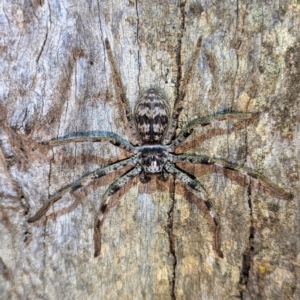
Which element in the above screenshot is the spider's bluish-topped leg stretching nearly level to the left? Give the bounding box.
[41,131,134,153]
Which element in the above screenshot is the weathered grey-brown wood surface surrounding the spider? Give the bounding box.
[0,0,300,300]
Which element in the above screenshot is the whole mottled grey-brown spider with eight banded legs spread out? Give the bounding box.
[28,38,292,257]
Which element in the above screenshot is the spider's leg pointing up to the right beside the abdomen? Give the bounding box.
[163,37,202,145]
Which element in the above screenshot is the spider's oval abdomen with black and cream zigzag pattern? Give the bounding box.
[134,88,170,143]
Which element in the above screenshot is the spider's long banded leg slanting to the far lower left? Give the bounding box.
[28,157,136,223]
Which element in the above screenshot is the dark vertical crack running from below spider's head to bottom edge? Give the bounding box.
[167,177,177,300]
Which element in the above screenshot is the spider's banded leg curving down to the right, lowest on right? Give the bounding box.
[165,162,223,257]
